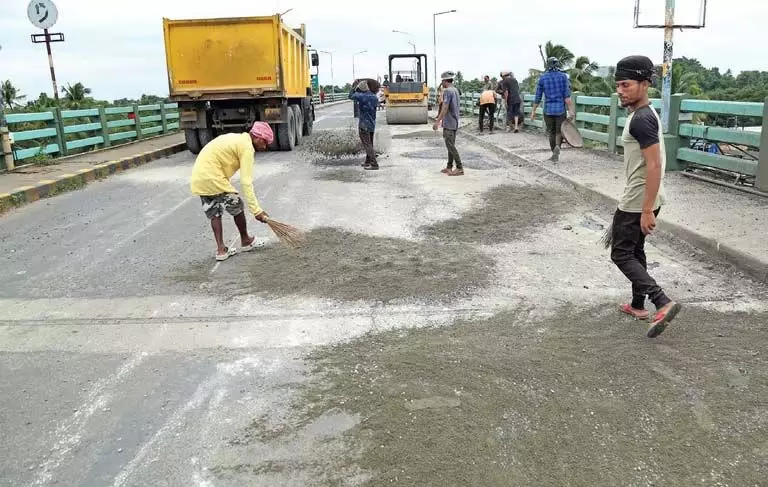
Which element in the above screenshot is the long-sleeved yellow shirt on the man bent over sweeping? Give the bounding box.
[189,133,262,215]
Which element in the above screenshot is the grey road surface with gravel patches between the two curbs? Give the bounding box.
[0,101,768,486]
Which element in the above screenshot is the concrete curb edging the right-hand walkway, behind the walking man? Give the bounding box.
[444,117,768,282]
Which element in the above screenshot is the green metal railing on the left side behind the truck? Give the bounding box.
[0,103,179,169]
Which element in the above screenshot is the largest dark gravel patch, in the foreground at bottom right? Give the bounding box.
[294,303,768,486]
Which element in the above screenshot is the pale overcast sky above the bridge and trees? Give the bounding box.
[0,0,768,100]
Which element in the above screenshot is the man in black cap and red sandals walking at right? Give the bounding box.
[610,52,681,338]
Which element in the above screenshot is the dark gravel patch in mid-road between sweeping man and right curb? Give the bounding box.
[422,185,586,245]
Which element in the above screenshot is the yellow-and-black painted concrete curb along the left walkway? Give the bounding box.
[0,143,187,214]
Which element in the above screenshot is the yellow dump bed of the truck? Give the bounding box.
[163,15,310,101]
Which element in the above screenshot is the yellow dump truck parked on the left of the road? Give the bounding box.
[163,15,319,154]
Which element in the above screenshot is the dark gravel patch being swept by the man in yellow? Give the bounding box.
[176,228,494,302]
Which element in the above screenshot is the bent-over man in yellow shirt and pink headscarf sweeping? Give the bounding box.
[189,122,274,261]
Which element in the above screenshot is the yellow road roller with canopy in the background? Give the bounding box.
[384,54,429,125]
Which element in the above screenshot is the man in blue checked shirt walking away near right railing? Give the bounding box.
[531,57,573,162]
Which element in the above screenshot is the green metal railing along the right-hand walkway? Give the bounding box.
[430,92,768,191]
